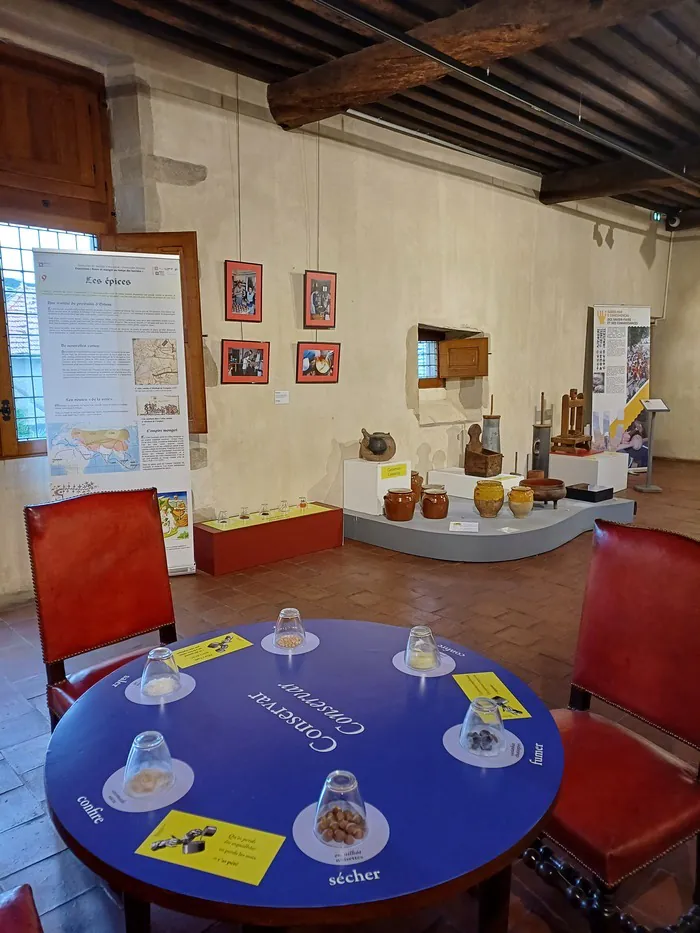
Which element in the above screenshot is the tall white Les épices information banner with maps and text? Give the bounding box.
[34,250,194,573]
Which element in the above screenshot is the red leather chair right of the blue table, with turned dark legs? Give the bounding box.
[525,521,700,933]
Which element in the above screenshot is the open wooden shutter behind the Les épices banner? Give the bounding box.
[100,231,207,434]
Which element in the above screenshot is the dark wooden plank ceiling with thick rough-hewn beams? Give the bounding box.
[63,0,700,227]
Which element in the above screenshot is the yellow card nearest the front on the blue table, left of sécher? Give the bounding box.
[136,810,285,885]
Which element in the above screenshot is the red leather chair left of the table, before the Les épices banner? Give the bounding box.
[24,489,177,729]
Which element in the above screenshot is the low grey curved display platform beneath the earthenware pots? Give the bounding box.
[343,496,635,563]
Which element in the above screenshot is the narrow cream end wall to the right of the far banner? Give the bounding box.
[651,234,700,460]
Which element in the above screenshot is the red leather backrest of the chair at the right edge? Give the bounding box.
[573,521,700,747]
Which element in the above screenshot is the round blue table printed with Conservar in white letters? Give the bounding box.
[46,619,563,933]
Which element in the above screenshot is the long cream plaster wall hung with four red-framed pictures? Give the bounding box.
[0,0,668,594]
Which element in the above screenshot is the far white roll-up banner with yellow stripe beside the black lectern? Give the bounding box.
[591,305,651,468]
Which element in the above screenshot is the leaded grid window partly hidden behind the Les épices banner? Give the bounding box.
[0,222,97,441]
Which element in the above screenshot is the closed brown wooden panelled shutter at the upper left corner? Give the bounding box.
[0,42,114,233]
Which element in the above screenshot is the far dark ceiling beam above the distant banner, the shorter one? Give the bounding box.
[540,146,700,204]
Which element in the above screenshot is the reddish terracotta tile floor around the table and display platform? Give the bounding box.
[0,463,700,933]
